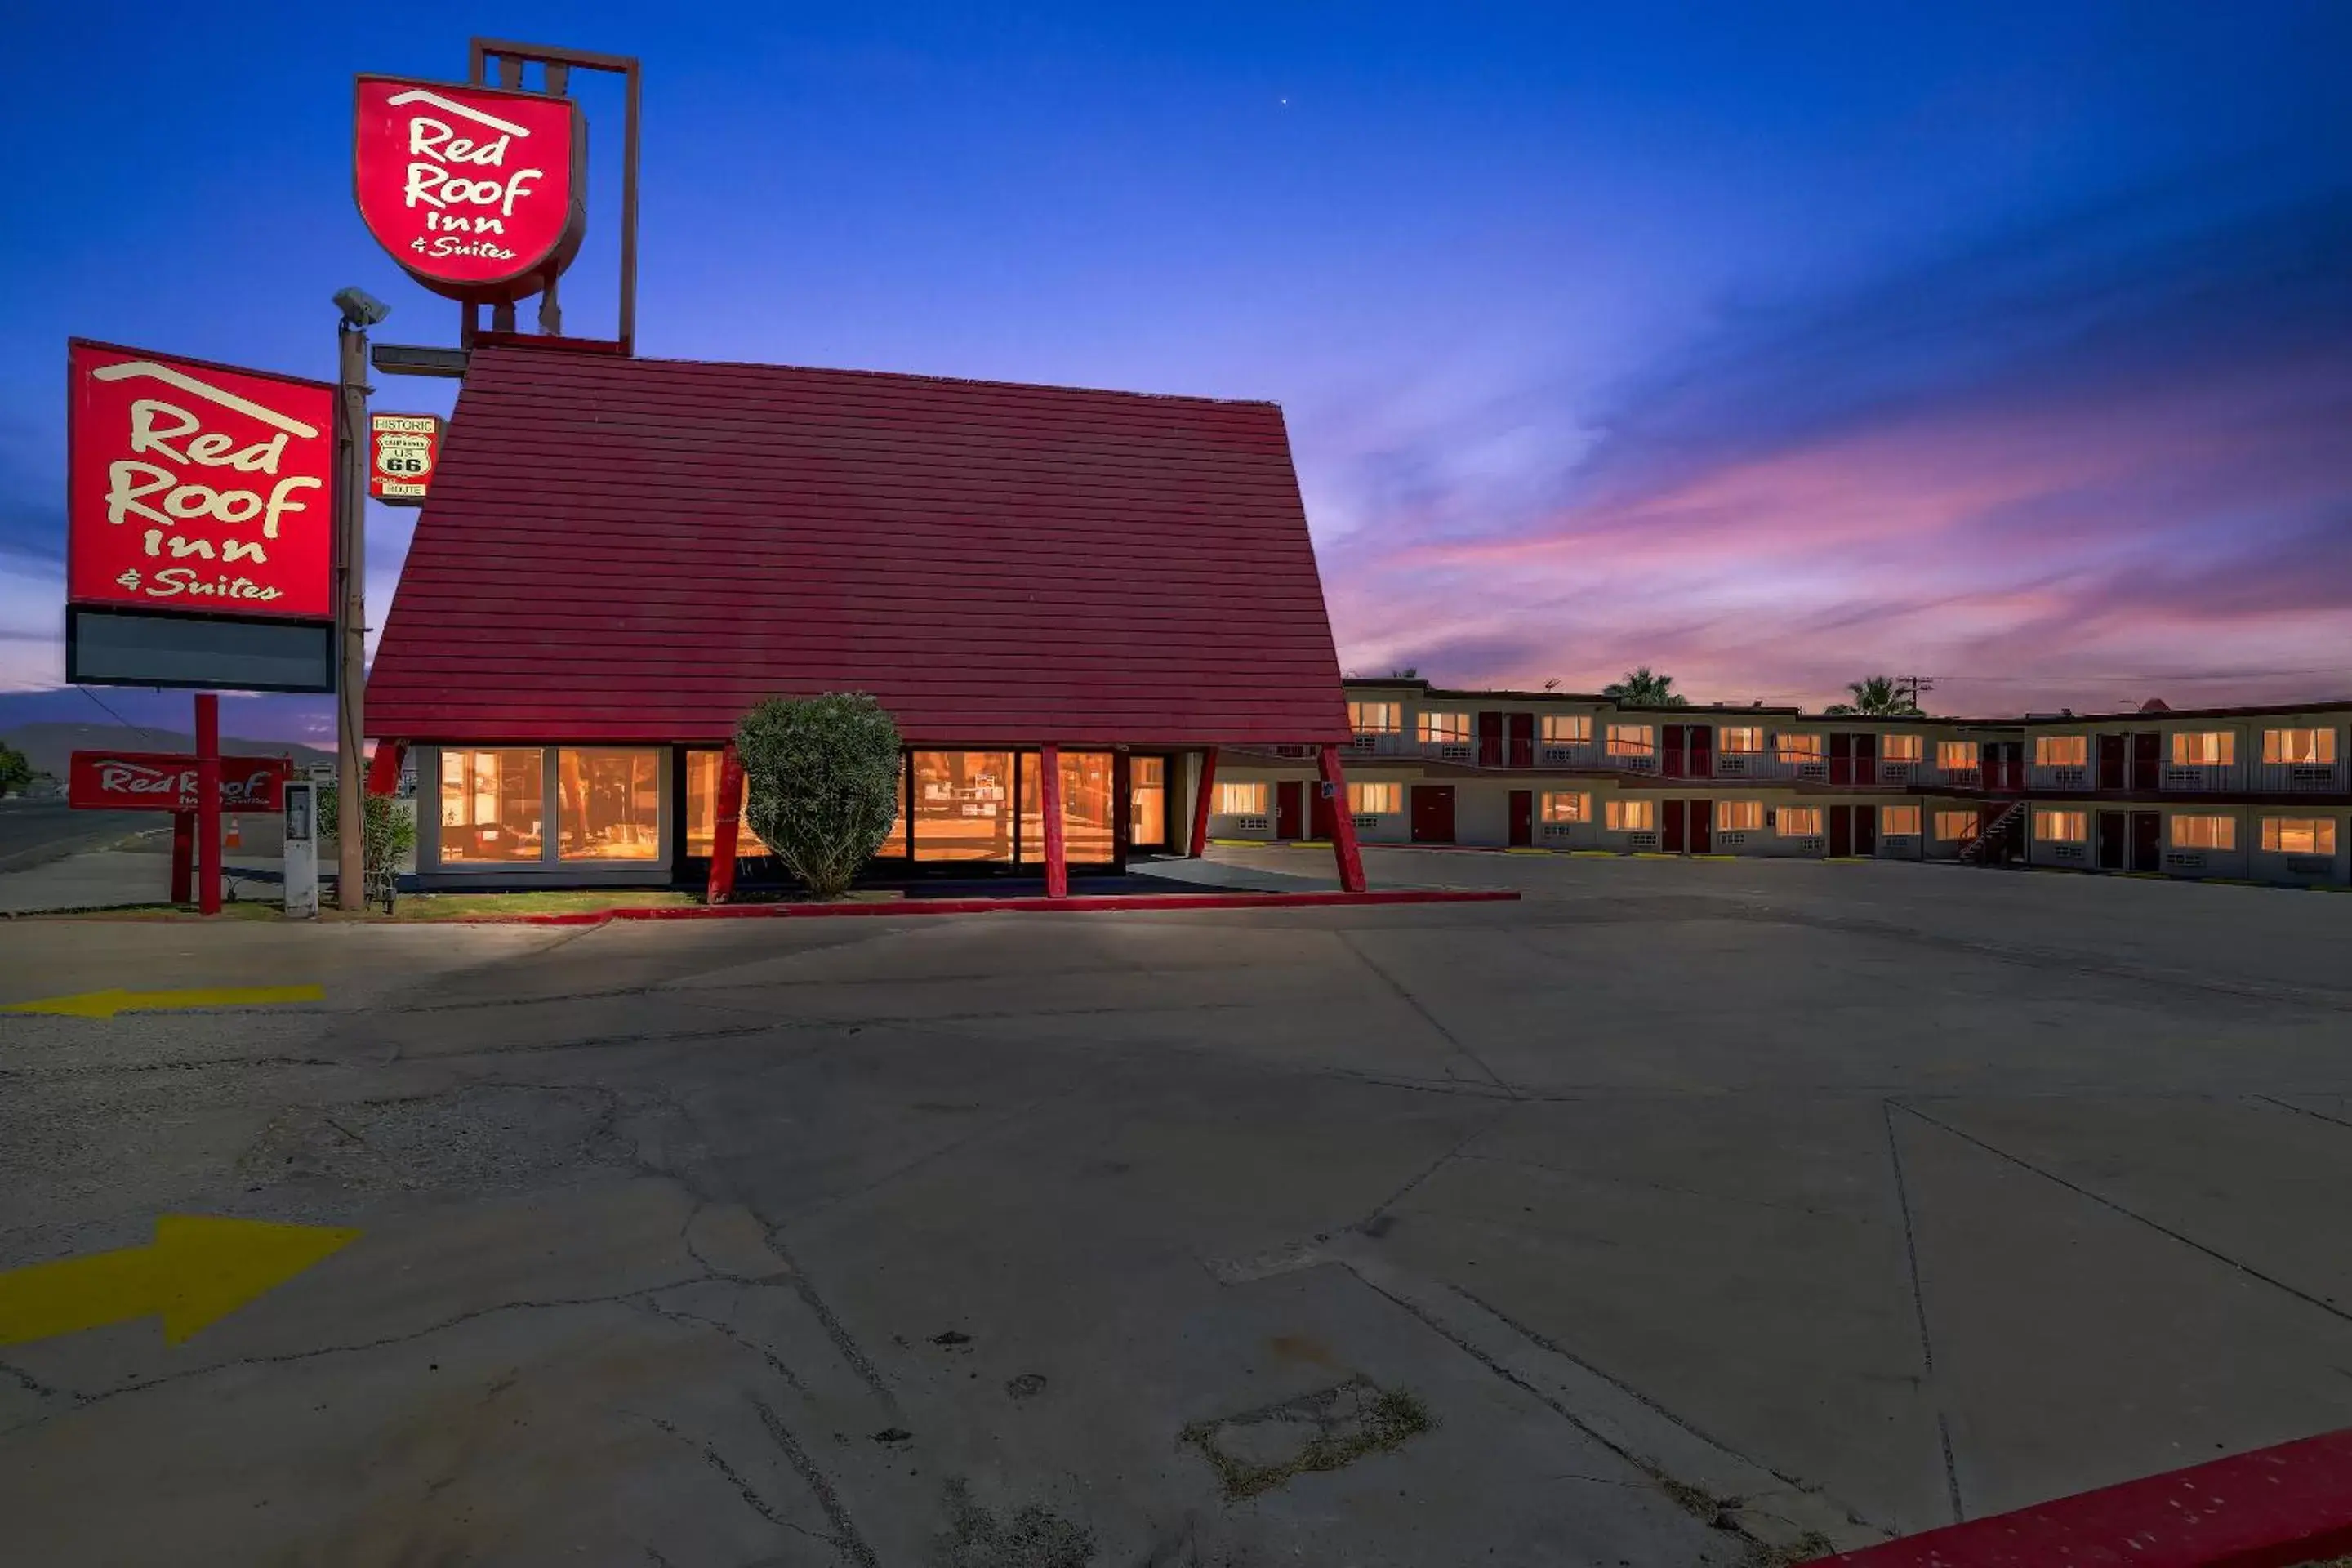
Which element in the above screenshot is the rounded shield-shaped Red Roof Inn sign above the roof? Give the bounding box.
[350,75,588,303]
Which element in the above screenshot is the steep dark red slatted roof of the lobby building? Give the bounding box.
[367,345,1348,746]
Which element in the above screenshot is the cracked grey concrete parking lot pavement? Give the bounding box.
[0,851,2352,1568]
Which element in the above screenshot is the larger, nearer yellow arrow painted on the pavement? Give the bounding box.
[0,1213,360,1345]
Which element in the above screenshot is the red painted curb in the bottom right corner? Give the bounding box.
[1815,1427,2352,1568]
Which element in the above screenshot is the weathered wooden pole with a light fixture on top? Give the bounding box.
[334,289,393,912]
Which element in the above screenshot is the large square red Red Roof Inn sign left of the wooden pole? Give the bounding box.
[66,339,334,621]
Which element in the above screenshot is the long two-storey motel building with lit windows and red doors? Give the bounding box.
[1209,679,2352,886]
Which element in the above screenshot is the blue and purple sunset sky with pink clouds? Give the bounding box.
[0,0,2352,733]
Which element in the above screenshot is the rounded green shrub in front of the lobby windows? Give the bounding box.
[736,691,901,898]
